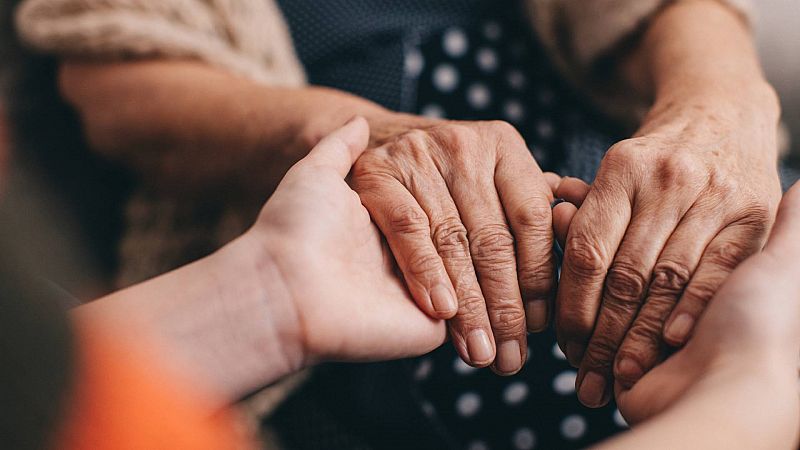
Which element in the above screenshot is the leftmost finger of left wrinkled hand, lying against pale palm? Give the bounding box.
[355,177,458,319]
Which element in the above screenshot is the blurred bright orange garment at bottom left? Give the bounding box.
[54,329,251,450]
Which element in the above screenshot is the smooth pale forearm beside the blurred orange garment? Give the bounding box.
[74,230,305,406]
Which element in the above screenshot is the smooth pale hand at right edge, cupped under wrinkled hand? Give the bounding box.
[616,185,800,426]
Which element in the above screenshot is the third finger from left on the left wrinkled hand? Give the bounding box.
[448,157,536,375]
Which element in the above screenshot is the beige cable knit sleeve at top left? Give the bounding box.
[16,0,305,86]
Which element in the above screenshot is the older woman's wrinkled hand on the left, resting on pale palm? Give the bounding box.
[352,114,555,374]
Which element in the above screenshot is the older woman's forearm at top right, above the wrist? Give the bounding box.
[624,0,779,131]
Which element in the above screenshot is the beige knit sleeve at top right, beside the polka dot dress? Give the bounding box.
[526,0,752,122]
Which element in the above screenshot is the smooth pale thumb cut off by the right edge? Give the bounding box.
[764,183,800,262]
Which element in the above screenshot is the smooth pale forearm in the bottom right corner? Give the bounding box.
[598,358,800,450]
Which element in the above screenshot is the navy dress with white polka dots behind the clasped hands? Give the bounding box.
[280,0,625,450]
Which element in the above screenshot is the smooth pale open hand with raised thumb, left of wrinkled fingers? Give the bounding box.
[253,119,446,364]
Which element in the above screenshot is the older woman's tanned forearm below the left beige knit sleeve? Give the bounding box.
[60,61,390,198]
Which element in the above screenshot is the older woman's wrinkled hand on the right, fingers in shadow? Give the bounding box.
[556,101,780,407]
